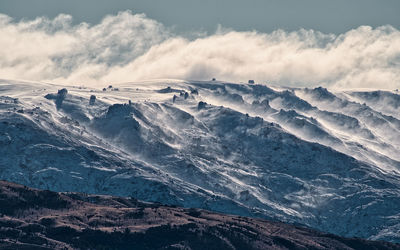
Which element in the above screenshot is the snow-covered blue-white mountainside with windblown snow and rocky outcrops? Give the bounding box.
[0,80,400,242]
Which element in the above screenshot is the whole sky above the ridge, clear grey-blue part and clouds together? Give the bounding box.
[0,0,400,89]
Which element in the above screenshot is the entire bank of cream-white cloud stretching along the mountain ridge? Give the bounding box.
[0,11,400,89]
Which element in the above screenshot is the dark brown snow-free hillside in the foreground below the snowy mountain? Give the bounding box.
[0,182,400,250]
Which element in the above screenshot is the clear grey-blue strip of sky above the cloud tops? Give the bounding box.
[0,0,400,33]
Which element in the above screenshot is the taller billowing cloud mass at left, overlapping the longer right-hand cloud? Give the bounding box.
[0,12,169,82]
